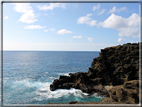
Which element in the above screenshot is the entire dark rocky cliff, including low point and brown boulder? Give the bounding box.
[50,43,139,104]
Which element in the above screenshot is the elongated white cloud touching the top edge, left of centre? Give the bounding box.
[37,3,66,10]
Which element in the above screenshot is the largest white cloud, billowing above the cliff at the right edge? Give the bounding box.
[98,13,140,37]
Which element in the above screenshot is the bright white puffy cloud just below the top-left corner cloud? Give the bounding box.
[19,10,37,23]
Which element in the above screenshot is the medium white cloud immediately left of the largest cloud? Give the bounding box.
[77,13,97,26]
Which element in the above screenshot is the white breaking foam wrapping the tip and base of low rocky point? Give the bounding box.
[36,85,103,100]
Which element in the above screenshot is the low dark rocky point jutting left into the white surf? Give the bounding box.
[50,72,109,96]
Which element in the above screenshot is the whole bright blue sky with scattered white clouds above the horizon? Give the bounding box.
[3,3,140,51]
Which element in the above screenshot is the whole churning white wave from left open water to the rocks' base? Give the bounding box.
[9,79,103,101]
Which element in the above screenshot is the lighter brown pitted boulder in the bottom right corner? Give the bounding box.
[109,80,139,104]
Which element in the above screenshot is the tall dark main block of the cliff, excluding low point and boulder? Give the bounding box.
[88,43,139,85]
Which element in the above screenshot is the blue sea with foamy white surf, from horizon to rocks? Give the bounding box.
[3,51,103,104]
